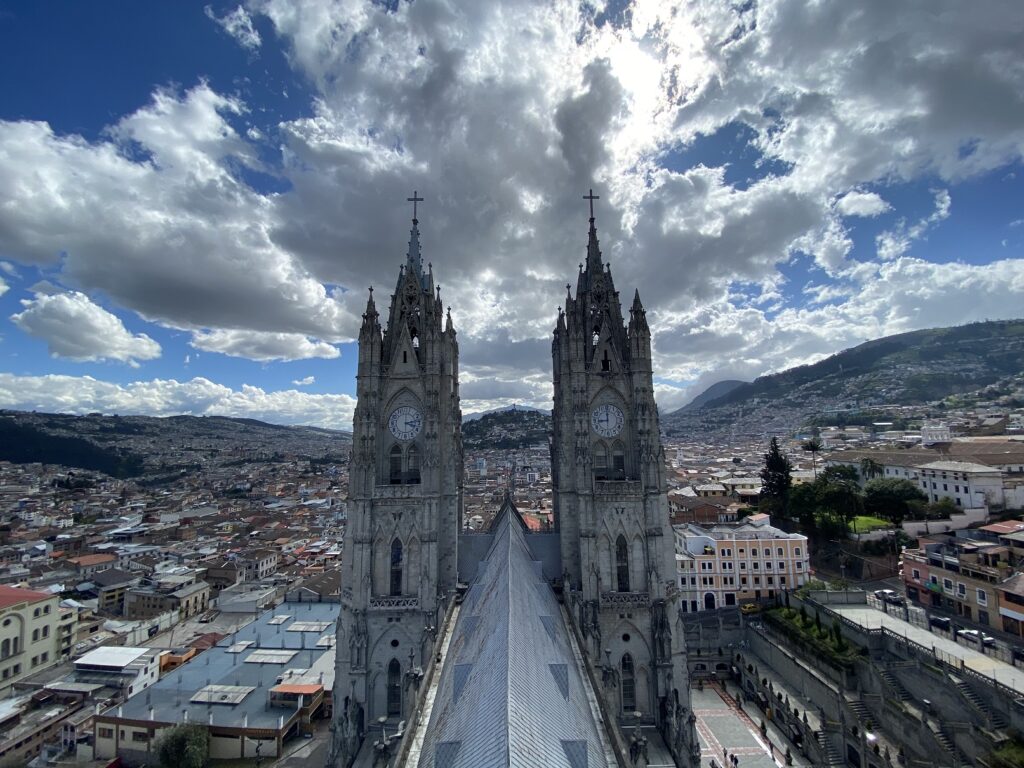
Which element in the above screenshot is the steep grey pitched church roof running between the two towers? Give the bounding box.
[419,506,606,768]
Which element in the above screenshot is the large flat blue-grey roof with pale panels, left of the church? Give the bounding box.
[105,602,341,728]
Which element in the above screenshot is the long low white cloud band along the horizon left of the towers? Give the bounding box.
[0,374,355,429]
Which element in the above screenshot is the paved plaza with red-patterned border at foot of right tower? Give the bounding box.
[692,684,810,768]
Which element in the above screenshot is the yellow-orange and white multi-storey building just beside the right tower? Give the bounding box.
[673,514,810,612]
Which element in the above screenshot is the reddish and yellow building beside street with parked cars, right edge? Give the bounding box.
[900,539,1013,630]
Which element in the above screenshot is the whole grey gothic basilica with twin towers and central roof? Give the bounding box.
[328,193,699,768]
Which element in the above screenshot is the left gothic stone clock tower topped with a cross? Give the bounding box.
[328,201,463,768]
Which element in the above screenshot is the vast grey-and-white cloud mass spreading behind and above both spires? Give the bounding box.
[0,0,1024,410]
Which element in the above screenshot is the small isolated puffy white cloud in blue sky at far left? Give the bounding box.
[10,291,161,366]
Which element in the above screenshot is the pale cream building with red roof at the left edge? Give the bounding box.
[0,585,77,698]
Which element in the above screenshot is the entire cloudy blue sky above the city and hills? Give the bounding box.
[0,0,1024,429]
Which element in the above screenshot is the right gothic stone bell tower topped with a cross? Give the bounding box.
[551,190,699,765]
